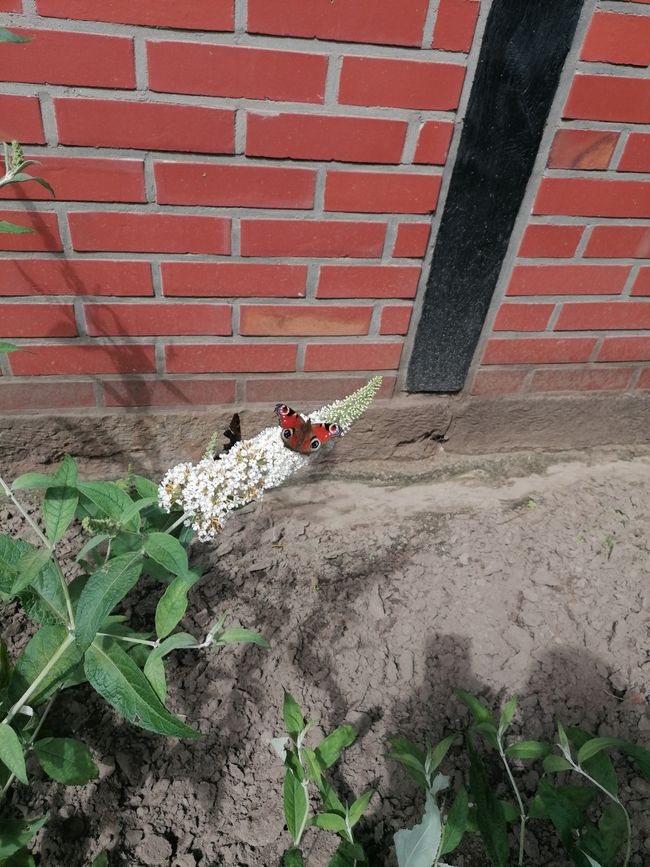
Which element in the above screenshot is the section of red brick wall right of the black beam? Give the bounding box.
[471,2,650,394]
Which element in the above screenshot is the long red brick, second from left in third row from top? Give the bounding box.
[54,99,235,154]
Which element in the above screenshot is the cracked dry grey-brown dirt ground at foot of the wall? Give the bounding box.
[3,450,650,867]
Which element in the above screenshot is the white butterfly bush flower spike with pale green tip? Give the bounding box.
[158,376,381,542]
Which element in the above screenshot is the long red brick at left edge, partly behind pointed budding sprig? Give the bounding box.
[0,156,147,202]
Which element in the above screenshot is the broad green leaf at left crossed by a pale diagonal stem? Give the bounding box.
[9,626,81,706]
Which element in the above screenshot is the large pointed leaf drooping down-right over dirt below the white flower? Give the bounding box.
[84,639,199,737]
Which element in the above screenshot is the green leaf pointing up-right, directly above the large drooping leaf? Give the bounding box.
[75,552,142,650]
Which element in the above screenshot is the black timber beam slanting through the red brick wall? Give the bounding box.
[407,0,583,392]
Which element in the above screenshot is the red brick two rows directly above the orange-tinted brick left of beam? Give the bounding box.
[241,220,386,259]
